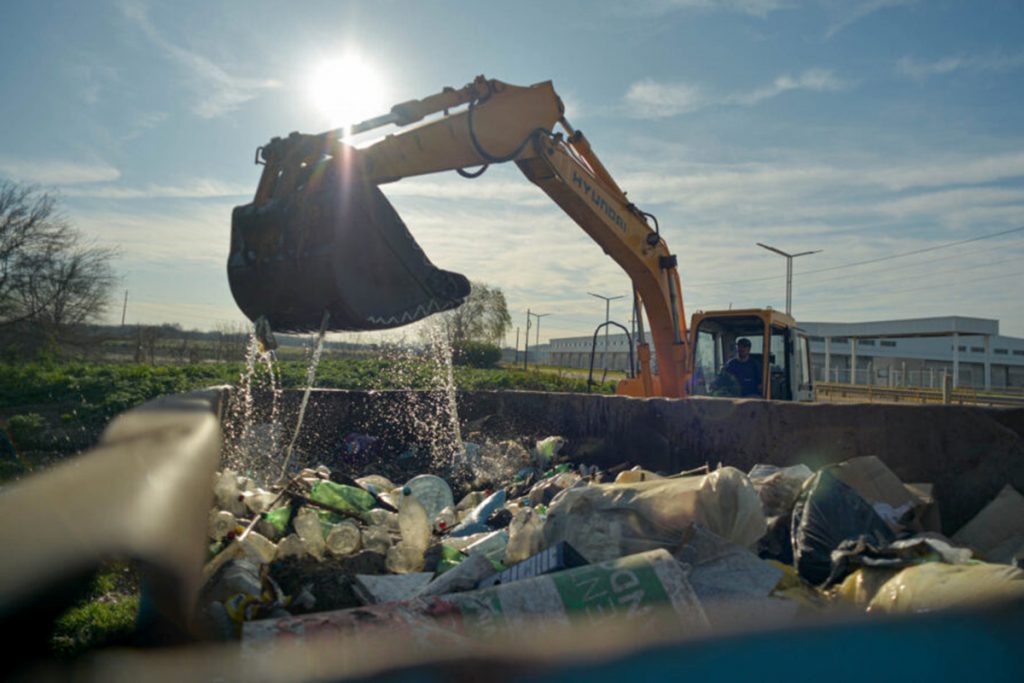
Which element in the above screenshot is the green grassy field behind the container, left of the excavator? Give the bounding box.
[0,357,612,481]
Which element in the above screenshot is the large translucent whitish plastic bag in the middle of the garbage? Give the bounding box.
[544,467,765,562]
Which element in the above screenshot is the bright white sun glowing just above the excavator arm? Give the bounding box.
[308,54,388,128]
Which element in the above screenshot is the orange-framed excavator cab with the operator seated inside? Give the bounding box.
[689,309,814,400]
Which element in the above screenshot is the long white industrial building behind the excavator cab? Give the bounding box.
[546,315,1024,389]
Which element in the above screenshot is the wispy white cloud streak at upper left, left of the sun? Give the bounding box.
[121,0,281,119]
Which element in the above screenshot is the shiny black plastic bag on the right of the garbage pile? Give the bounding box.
[793,467,895,586]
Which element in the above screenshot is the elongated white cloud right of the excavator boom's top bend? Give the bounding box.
[625,69,851,119]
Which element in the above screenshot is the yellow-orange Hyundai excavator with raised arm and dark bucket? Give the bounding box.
[227,76,812,400]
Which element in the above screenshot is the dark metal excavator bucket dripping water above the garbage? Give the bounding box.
[227,151,469,332]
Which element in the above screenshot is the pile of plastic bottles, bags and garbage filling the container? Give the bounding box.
[201,436,1024,641]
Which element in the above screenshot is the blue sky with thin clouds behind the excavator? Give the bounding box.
[0,0,1024,342]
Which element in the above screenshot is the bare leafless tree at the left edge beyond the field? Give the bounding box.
[0,180,117,350]
